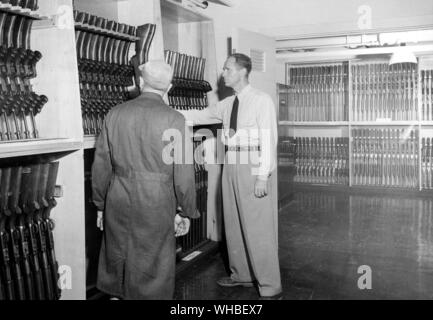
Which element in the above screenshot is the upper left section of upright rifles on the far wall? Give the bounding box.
[285,63,348,121]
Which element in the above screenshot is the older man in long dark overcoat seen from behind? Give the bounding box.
[92,61,199,299]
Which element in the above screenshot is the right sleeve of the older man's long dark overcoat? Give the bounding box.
[172,115,200,218]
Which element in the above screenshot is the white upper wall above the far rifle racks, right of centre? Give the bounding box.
[195,0,433,70]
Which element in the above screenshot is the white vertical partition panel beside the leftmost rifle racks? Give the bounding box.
[31,0,86,300]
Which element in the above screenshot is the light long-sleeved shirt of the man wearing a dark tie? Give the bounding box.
[180,85,278,177]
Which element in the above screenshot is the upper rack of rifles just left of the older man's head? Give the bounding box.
[74,10,156,135]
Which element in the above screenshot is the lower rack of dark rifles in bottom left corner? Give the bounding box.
[0,162,61,300]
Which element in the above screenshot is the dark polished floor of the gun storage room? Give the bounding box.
[175,189,433,300]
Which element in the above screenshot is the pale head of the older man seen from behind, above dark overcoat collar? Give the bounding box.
[139,60,173,91]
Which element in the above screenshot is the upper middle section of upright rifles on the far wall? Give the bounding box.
[351,62,418,121]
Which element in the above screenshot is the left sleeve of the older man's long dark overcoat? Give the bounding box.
[92,116,113,211]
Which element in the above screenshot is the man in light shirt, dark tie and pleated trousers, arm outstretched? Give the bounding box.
[178,54,282,299]
